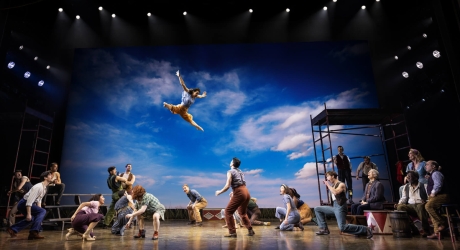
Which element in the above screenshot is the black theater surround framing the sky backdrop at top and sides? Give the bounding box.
[0,0,460,205]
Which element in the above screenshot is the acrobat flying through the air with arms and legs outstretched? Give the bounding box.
[163,70,206,131]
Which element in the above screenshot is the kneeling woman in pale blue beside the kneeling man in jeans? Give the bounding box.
[275,184,304,231]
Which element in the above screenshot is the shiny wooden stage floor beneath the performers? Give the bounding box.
[0,220,460,250]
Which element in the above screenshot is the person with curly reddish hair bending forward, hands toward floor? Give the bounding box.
[126,185,166,240]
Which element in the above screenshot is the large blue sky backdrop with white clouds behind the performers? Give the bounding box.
[60,41,391,208]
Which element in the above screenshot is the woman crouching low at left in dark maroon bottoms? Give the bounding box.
[65,194,105,241]
